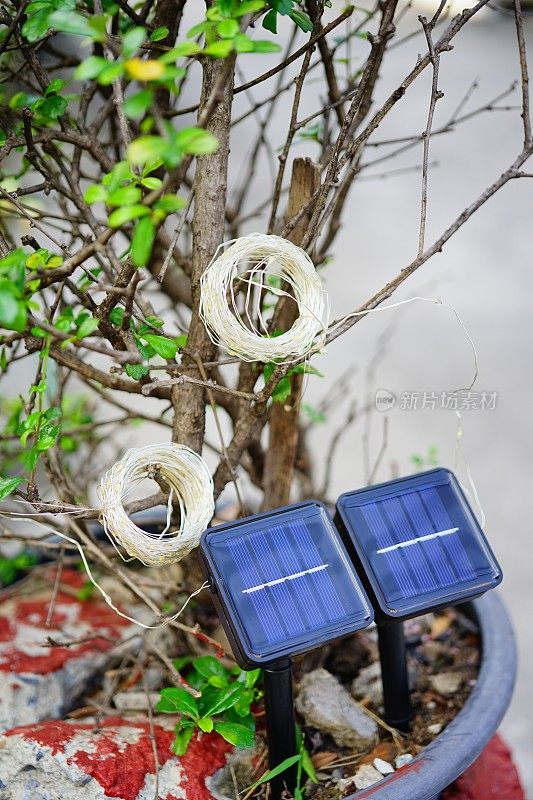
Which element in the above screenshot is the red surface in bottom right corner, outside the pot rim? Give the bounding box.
[442,736,525,800]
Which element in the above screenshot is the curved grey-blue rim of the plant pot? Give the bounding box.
[345,592,516,800]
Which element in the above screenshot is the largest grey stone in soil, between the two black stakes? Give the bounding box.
[296,669,377,748]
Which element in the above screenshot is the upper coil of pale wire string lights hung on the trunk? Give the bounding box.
[200,233,329,363]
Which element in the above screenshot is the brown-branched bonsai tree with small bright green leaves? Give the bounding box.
[0,0,533,744]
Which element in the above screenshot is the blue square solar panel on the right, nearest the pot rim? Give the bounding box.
[337,468,502,619]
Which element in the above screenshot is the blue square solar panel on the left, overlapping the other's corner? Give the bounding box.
[200,501,372,668]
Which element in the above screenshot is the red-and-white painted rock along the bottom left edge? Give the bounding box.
[0,717,232,800]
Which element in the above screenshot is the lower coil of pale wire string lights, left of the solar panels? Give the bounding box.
[98,443,215,566]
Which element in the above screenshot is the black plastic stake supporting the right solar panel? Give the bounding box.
[378,622,411,732]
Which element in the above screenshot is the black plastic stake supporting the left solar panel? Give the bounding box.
[263,660,297,800]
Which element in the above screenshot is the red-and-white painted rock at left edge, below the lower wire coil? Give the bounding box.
[0,570,134,730]
